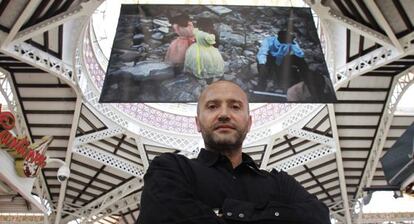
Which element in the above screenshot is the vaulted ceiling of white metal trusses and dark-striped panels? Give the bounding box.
[0,0,414,223]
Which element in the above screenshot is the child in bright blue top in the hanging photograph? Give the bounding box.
[256,31,307,91]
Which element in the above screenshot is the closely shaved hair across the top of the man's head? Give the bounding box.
[197,80,249,116]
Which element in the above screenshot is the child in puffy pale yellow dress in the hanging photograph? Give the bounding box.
[184,18,224,84]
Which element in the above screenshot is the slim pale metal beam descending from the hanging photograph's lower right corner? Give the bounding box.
[328,104,352,224]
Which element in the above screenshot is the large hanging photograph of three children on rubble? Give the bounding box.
[100,5,336,103]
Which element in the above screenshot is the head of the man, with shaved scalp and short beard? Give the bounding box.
[196,81,252,154]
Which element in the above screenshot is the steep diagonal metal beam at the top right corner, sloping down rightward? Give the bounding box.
[364,0,404,52]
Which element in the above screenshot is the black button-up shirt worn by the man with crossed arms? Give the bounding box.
[137,149,331,224]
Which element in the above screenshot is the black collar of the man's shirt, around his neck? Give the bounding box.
[197,149,262,174]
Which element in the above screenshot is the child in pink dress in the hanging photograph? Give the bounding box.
[165,14,195,65]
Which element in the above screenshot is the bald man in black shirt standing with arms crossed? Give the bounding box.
[137,81,330,224]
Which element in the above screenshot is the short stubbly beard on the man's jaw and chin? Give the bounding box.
[201,122,247,154]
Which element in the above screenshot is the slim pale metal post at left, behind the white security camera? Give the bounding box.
[55,95,82,224]
